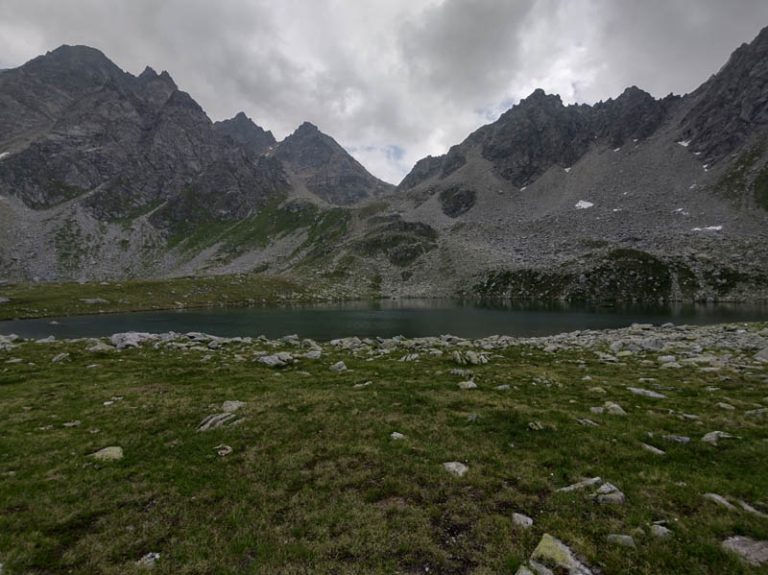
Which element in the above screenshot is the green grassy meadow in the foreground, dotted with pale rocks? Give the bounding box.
[0,330,768,575]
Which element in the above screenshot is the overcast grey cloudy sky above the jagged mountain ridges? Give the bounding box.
[0,0,768,182]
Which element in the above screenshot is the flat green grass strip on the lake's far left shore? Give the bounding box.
[0,274,308,320]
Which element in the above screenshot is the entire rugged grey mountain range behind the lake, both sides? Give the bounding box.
[0,30,768,302]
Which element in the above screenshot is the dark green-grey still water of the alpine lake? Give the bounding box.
[0,300,768,341]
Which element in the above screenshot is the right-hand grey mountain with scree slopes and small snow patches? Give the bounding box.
[308,24,768,302]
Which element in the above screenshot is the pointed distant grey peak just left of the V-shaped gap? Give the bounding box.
[272,122,394,206]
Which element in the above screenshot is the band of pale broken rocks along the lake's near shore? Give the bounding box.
[0,323,768,364]
